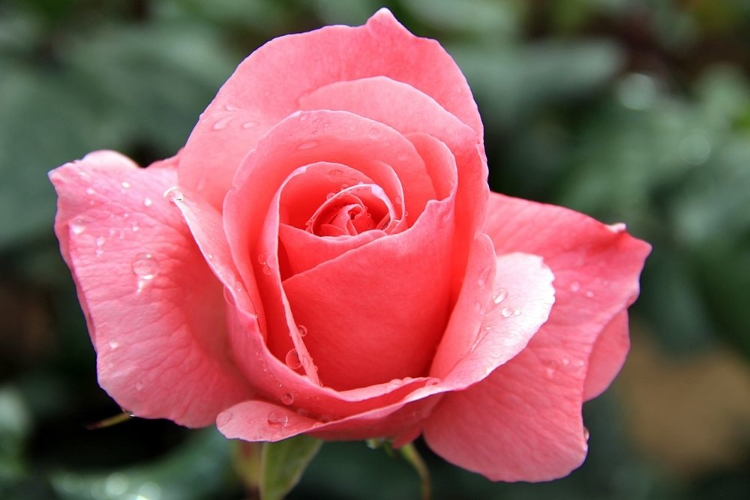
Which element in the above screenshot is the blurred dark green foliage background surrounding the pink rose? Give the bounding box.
[0,0,750,500]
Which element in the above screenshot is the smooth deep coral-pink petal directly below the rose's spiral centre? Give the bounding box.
[284,195,453,390]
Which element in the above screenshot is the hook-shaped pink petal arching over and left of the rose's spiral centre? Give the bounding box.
[224,111,428,368]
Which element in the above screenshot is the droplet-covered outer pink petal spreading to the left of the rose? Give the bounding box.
[50,152,252,426]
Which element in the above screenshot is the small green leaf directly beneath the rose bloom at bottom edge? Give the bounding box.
[260,436,323,500]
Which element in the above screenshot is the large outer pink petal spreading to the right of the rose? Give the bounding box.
[425,194,650,481]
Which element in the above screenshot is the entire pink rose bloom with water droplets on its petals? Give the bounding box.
[50,10,650,481]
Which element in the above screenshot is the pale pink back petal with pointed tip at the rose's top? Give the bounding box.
[180,9,482,207]
